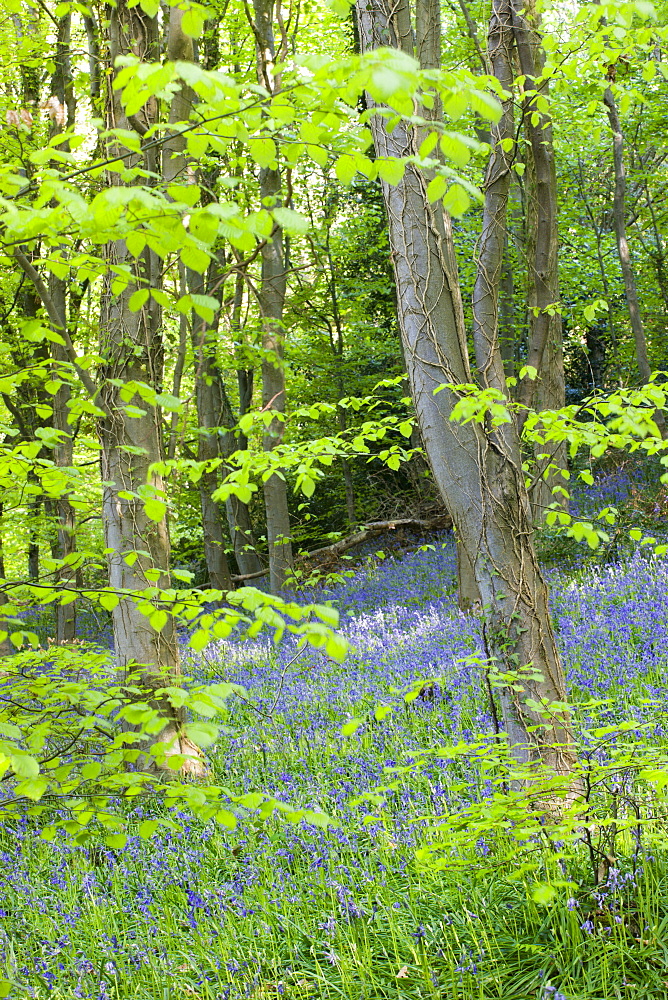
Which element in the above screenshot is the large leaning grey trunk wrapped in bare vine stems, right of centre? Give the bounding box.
[357,0,573,773]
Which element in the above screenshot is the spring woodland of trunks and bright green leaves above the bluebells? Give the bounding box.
[0,0,668,995]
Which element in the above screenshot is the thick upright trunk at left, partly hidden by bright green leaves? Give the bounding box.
[100,0,202,773]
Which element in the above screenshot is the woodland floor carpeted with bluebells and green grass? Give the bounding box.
[0,472,668,1000]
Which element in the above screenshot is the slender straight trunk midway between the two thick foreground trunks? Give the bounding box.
[253,0,293,594]
